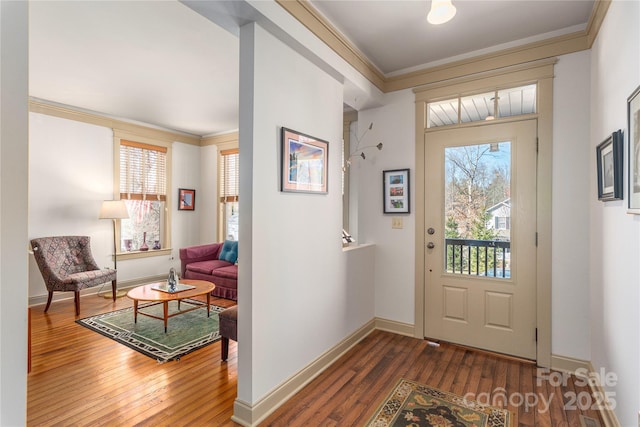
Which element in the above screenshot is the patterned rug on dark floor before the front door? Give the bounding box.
[367,379,511,427]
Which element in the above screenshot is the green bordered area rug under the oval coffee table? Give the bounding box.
[76,300,224,362]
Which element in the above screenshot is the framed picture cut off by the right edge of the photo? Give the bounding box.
[627,86,640,215]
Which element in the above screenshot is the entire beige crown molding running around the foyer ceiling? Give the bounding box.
[276,0,611,93]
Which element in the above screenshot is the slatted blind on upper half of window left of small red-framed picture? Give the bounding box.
[120,140,167,201]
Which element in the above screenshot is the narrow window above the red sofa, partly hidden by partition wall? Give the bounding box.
[218,149,240,240]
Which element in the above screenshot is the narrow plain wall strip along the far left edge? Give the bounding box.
[0,1,28,426]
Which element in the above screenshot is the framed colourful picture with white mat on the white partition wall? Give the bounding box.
[280,127,329,194]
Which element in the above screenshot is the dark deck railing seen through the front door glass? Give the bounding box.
[445,239,511,278]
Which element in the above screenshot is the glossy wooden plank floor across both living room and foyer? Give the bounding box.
[27,296,602,427]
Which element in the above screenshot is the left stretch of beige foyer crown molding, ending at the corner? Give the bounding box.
[276,0,385,90]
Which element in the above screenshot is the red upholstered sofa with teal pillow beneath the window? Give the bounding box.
[180,243,238,301]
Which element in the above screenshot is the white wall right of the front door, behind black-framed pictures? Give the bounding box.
[589,1,640,426]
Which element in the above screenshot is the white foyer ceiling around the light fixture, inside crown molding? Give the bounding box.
[311,0,594,77]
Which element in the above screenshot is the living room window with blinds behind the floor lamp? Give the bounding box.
[119,140,167,252]
